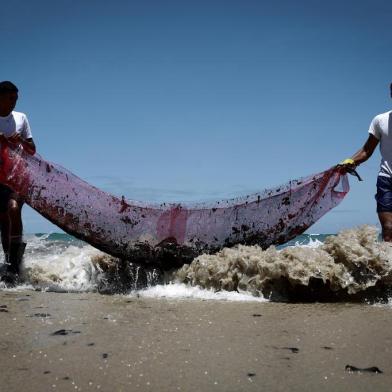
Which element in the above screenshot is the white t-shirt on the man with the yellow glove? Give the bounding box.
[369,111,392,177]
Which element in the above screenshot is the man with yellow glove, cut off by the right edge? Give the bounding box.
[342,83,392,242]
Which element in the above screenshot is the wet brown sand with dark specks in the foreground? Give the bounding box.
[0,291,392,391]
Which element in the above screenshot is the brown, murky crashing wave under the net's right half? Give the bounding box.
[172,226,392,301]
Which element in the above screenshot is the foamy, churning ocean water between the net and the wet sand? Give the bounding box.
[0,226,392,302]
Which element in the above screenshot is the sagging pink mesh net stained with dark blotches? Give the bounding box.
[0,145,349,268]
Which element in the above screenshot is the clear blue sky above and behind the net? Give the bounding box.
[0,0,392,233]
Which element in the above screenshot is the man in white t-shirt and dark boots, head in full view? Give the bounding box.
[0,81,35,281]
